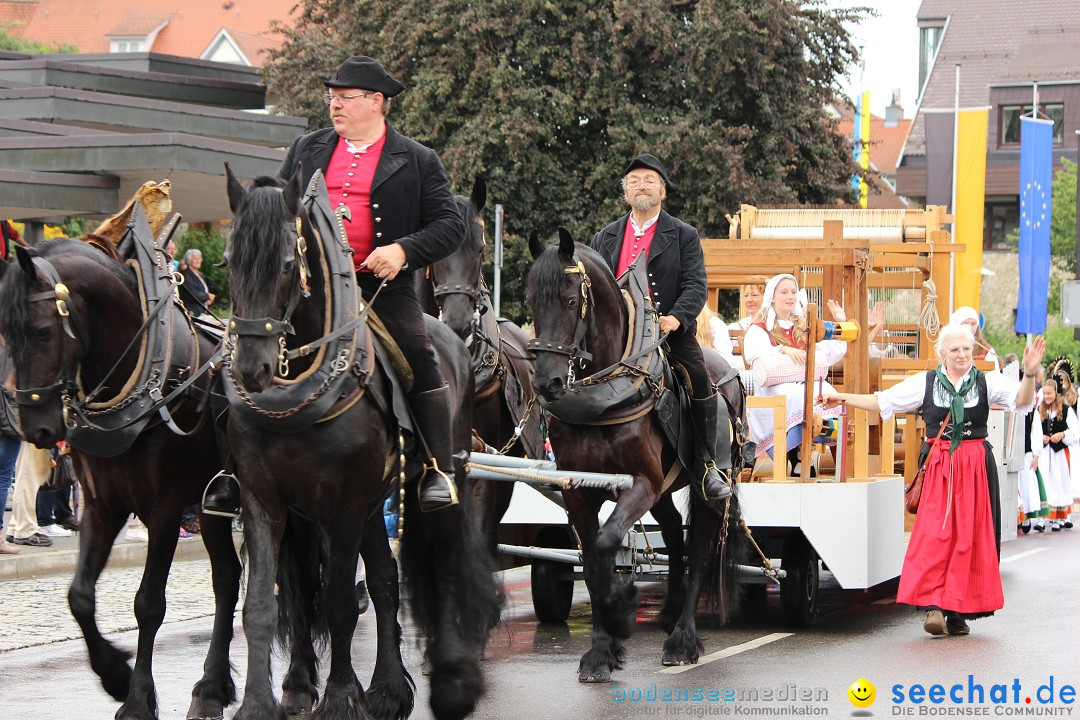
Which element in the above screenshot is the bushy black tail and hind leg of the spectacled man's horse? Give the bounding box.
[402,486,504,718]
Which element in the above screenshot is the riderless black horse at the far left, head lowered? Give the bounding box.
[0,239,240,720]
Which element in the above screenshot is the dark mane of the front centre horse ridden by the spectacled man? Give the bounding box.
[229,175,291,306]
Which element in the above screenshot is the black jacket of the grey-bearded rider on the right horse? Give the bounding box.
[593,210,708,332]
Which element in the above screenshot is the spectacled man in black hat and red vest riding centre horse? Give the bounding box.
[205,56,464,518]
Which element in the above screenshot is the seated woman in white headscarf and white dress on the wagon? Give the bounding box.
[743,274,848,475]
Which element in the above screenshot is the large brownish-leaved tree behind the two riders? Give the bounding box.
[267,0,861,318]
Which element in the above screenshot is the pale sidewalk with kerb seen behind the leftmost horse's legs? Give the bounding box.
[0,513,234,582]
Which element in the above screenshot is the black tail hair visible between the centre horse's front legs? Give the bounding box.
[278,512,329,656]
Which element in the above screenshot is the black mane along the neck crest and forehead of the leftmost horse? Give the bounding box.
[0,237,137,358]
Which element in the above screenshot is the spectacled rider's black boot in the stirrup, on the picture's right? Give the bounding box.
[408,385,458,513]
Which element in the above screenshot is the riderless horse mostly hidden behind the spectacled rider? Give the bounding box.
[418,177,543,549]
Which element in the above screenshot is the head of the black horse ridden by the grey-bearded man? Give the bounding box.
[526,228,626,402]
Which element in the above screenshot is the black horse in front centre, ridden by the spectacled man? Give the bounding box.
[225,169,500,720]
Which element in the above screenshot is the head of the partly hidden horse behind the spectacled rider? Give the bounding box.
[431,177,487,341]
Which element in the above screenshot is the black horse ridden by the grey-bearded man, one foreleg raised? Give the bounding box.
[527,229,743,682]
